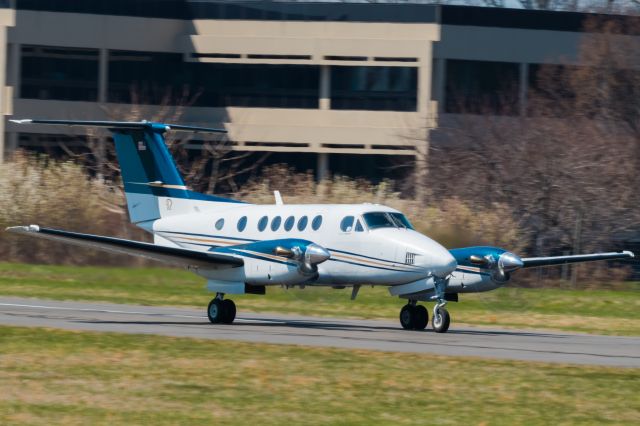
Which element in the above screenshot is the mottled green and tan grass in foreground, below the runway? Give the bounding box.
[0,327,640,425]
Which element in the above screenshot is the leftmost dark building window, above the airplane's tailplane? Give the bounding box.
[20,46,99,102]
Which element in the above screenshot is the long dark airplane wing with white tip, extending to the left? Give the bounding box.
[6,225,244,269]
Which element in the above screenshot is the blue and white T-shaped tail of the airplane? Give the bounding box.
[11,119,245,229]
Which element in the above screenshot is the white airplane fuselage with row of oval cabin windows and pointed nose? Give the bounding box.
[153,200,456,292]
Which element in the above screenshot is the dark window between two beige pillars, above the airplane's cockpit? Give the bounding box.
[331,66,418,111]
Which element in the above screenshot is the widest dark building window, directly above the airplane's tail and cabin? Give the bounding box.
[109,50,320,108]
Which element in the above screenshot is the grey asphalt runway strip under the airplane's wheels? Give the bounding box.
[0,297,640,368]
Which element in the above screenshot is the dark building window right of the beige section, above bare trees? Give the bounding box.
[445,59,520,115]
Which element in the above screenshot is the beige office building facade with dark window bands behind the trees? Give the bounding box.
[0,0,635,177]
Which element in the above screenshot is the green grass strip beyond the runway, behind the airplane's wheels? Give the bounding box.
[0,263,640,335]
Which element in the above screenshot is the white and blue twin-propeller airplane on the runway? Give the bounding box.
[7,120,634,333]
